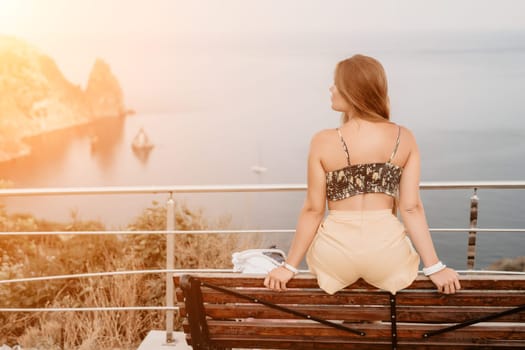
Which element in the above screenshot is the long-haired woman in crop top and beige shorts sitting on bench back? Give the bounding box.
[264,55,461,294]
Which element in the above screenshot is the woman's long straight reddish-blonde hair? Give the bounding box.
[334,55,390,123]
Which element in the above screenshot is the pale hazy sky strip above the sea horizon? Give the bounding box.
[0,0,525,39]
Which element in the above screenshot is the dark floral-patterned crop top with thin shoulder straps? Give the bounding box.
[326,127,403,201]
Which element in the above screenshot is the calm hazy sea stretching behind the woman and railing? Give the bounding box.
[0,32,525,269]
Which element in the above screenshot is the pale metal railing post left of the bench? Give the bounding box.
[166,192,175,344]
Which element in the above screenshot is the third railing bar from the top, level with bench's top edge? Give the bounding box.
[4,269,525,285]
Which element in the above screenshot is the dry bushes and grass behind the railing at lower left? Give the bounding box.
[0,202,239,349]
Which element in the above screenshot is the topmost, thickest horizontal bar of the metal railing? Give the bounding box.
[0,181,525,197]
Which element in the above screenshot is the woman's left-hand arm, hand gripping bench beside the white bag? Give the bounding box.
[264,132,326,290]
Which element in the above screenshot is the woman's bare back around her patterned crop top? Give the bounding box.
[320,120,412,210]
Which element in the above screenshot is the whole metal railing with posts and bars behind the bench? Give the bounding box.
[0,181,525,343]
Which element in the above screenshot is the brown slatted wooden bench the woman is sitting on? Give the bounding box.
[175,273,525,350]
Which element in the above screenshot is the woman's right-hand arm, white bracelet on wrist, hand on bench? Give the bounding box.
[399,129,461,294]
